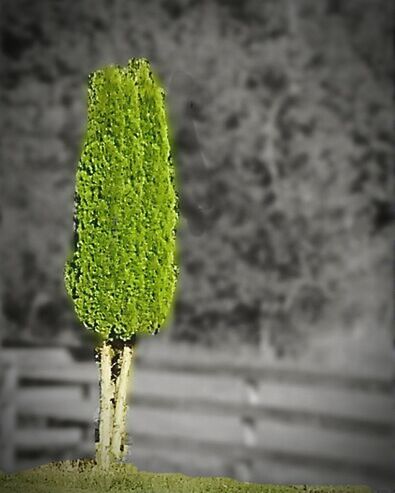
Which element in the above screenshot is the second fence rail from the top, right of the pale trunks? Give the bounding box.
[132,368,395,428]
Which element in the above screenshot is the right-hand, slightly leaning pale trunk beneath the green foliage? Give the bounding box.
[111,346,133,461]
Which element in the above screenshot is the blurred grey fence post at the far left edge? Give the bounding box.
[0,358,18,473]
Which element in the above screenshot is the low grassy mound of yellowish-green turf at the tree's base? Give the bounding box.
[0,460,371,493]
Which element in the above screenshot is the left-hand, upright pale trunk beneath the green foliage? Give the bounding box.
[96,343,114,469]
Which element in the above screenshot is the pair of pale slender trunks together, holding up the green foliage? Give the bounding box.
[96,344,133,469]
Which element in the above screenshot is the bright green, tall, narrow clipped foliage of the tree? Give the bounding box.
[65,59,178,341]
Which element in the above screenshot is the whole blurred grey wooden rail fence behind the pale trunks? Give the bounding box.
[0,344,395,487]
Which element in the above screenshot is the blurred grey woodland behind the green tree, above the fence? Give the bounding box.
[0,0,395,488]
